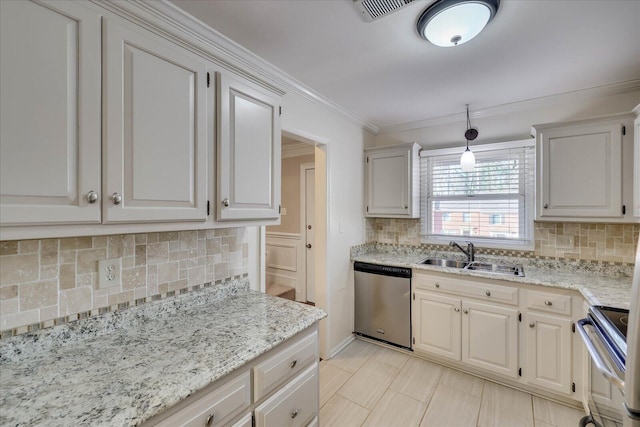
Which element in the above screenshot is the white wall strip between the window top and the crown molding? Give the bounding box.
[367,91,640,149]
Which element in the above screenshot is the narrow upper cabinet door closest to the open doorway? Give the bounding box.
[216,73,281,221]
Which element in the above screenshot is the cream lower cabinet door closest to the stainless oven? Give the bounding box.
[526,313,571,394]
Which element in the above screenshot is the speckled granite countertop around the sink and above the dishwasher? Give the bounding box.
[351,245,633,309]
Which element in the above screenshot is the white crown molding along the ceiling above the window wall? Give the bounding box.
[377,79,640,135]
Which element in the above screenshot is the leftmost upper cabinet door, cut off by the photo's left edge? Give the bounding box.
[0,1,100,225]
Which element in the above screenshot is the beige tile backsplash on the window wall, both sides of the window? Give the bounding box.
[366,218,640,264]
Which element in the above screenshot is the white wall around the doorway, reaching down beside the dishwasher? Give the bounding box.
[282,93,373,358]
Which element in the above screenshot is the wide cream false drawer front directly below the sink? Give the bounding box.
[414,274,518,305]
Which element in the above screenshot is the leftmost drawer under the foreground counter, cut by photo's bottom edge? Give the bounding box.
[156,372,251,427]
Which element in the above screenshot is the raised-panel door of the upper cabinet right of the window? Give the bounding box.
[538,122,622,219]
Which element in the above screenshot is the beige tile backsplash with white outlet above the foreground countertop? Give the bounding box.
[0,228,248,335]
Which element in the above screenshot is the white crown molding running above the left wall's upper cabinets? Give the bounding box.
[114,0,379,134]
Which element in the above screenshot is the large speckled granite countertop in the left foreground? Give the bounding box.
[0,280,326,426]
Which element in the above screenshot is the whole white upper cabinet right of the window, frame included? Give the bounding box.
[532,115,633,222]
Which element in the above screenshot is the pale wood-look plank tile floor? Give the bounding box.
[320,340,584,427]
